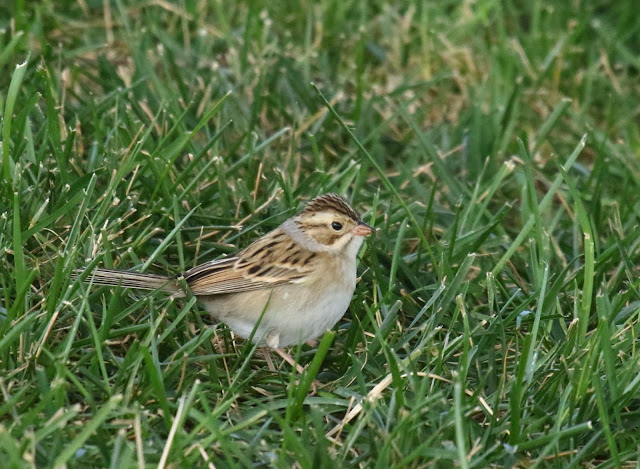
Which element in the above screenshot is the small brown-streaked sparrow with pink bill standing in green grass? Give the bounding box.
[80,194,375,348]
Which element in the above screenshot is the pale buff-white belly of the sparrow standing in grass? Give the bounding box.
[202,275,355,347]
